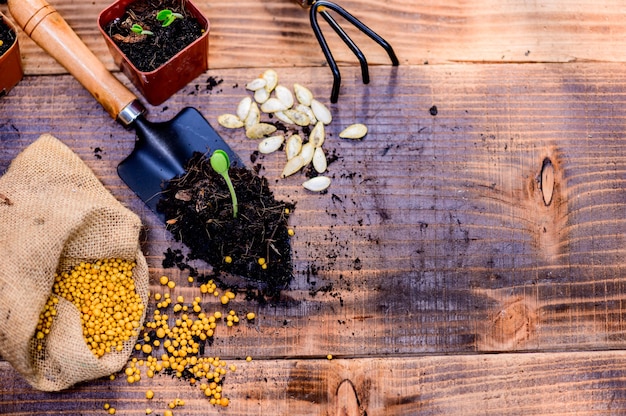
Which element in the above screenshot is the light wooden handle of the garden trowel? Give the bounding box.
[9,0,140,124]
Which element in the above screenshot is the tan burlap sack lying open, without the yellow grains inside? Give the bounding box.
[0,135,148,391]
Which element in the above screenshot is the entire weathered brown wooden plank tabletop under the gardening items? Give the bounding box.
[0,0,626,416]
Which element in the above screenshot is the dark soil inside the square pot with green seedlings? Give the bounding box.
[104,0,203,72]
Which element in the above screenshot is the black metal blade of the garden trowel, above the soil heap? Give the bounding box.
[117,107,244,220]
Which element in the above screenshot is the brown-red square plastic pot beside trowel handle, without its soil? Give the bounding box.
[98,0,210,105]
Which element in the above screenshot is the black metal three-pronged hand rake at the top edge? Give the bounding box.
[294,0,399,103]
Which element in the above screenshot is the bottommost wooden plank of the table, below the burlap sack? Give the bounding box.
[0,352,626,416]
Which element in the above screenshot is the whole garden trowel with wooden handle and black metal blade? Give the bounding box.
[8,0,244,219]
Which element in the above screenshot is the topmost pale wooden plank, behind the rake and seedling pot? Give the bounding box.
[0,0,626,74]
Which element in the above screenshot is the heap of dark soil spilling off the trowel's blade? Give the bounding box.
[157,153,294,297]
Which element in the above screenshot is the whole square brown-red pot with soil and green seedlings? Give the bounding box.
[97,0,209,106]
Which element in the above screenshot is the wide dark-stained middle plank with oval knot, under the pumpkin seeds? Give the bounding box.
[0,64,626,366]
